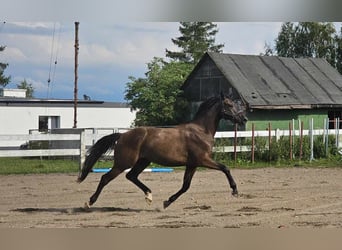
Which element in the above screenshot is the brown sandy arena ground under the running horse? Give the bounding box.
[0,168,342,228]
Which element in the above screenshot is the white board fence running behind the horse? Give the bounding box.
[0,128,342,169]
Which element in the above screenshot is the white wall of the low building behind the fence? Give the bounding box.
[0,106,135,134]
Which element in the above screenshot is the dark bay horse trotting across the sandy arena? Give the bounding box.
[78,94,247,208]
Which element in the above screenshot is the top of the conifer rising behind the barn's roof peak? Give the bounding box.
[166,22,224,64]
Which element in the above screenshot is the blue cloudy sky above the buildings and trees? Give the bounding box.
[0,20,340,102]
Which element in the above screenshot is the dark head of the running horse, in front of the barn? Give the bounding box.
[221,94,248,125]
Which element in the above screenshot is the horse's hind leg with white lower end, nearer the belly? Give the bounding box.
[126,159,152,204]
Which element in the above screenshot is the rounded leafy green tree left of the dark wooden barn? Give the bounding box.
[125,57,191,126]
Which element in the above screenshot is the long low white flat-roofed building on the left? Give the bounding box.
[0,88,135,135]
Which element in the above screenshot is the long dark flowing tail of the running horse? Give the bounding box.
[77,133,121,182]
